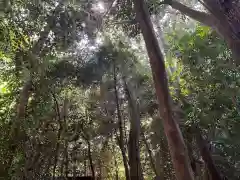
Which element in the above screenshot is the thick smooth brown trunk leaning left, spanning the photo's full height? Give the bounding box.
[133,0,193,180]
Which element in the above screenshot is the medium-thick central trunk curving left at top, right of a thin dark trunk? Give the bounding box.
[124,80,143,180]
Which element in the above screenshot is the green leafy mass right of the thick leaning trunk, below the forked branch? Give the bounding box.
[169,26,240,179]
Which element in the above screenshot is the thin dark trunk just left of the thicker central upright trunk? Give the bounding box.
[113,62,130,180]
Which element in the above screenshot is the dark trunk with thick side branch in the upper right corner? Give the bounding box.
[169,0,240,65]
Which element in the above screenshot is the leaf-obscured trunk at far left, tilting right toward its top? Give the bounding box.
[6,2,62,177]
